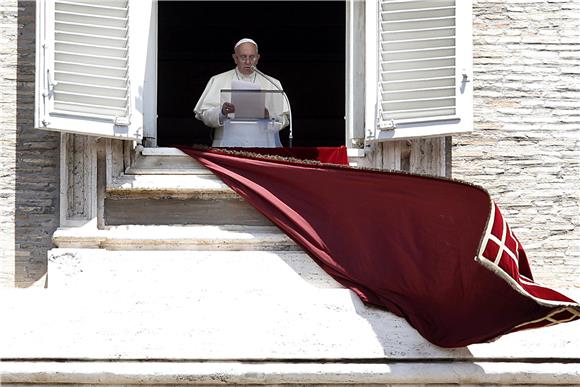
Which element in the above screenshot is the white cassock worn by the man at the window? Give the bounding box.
[193,69,290,147]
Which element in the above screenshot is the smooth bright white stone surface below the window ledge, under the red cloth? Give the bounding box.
[0,249,580,363]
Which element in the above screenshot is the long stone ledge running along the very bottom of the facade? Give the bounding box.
[0,361,580,386]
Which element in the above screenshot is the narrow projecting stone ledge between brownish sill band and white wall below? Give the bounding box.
[53,225,300,251]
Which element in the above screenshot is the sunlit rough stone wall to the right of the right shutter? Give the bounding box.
[453,0,580,287]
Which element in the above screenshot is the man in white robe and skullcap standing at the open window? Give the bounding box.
[193,39,290,147]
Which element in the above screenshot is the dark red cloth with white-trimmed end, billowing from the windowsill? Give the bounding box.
[181,147,580,347]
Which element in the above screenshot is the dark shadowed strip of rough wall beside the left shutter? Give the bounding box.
[14,0,60,287]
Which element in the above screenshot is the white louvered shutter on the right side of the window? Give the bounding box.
[368,0,472,140]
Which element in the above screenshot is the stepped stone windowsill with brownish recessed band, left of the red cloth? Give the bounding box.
[104,148,272,226]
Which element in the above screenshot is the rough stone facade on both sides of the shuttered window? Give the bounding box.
[0,0,580,287]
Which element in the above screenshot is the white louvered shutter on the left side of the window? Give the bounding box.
[36,0,142,139]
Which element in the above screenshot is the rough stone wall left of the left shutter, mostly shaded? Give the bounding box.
[0,0,59,287]
